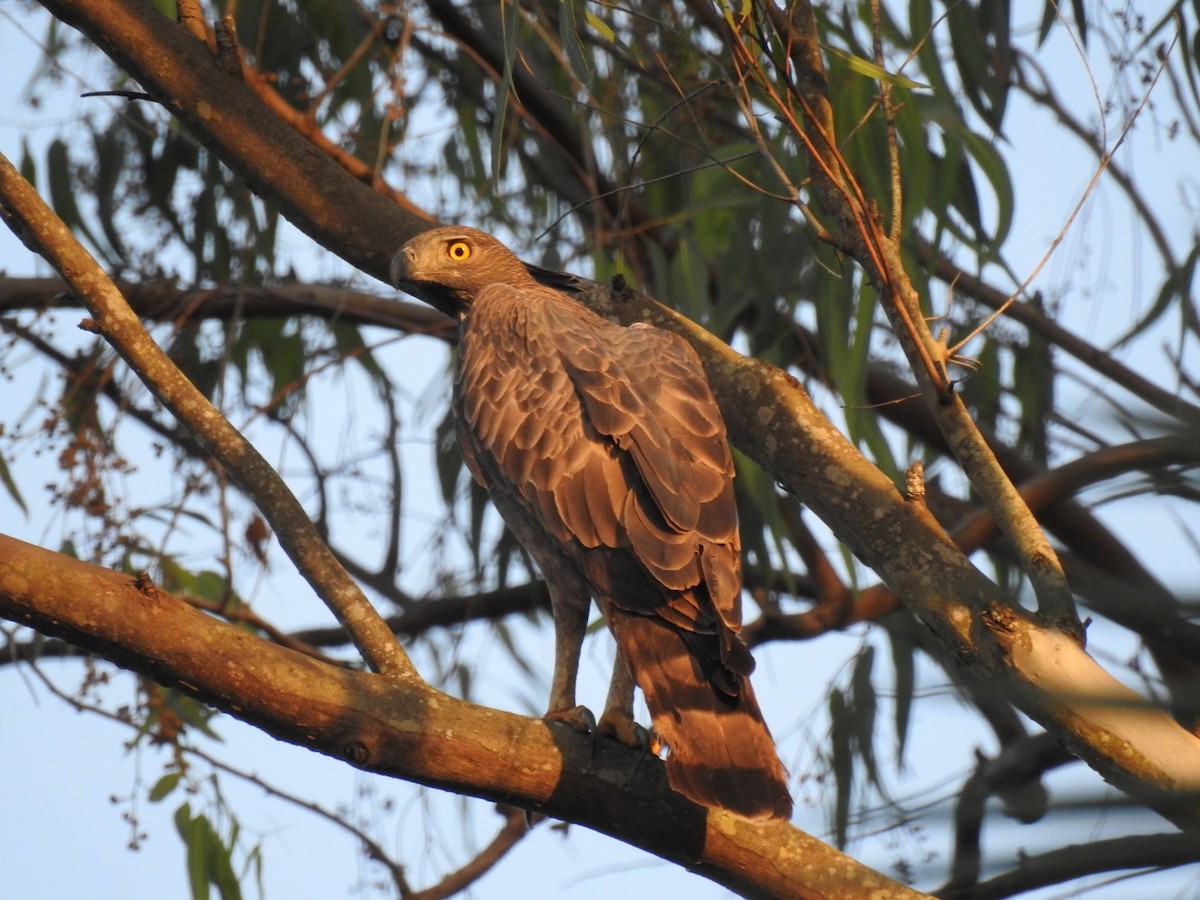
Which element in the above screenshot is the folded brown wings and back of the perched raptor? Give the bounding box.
[457,286,742,638]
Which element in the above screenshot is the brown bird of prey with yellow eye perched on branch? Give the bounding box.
[391,227,792,818]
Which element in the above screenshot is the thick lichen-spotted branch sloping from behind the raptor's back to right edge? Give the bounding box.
[576,277,1200,830]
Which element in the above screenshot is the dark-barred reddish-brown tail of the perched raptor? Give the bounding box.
[611,614,792,820]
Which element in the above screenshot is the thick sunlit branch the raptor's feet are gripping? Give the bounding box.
[0,536,923,900]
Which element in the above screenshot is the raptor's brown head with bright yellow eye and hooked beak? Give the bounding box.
[391,227,533,312]
